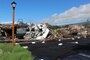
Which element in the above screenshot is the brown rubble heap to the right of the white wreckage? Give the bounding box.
[47,24,90,39]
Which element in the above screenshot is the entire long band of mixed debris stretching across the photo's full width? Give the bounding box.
[0,23,90,40]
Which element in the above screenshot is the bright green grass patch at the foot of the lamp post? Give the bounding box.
[0,44,34,60]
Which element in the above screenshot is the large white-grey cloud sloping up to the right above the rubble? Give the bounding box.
[44,4,90,24]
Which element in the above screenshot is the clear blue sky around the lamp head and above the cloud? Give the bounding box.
[0,0,90,23]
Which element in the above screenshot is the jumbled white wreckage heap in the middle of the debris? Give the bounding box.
[24,24,49,40]
